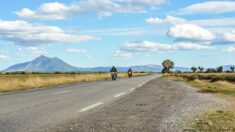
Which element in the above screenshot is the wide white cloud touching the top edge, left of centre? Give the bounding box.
[15,0,167,20]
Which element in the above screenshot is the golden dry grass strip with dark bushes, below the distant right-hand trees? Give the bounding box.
[164,73,235,97]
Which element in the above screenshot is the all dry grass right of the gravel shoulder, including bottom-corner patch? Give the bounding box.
[163,73,235,132]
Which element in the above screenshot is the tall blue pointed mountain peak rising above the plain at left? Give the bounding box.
[3,55,79,72]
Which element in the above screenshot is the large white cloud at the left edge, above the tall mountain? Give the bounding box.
[0,20,95,47]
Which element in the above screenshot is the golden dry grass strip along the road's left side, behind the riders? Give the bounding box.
[0,73,150,92]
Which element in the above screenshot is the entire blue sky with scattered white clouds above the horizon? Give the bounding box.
[0,0,235,70]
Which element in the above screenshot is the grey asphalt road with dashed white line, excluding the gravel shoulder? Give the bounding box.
[0,75,160,132]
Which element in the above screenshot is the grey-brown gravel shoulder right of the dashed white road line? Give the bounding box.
[50,78,229,132]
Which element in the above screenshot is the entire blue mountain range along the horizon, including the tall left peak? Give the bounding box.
[3,55,231,72]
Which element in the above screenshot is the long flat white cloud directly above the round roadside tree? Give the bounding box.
[122,41,212,53]
